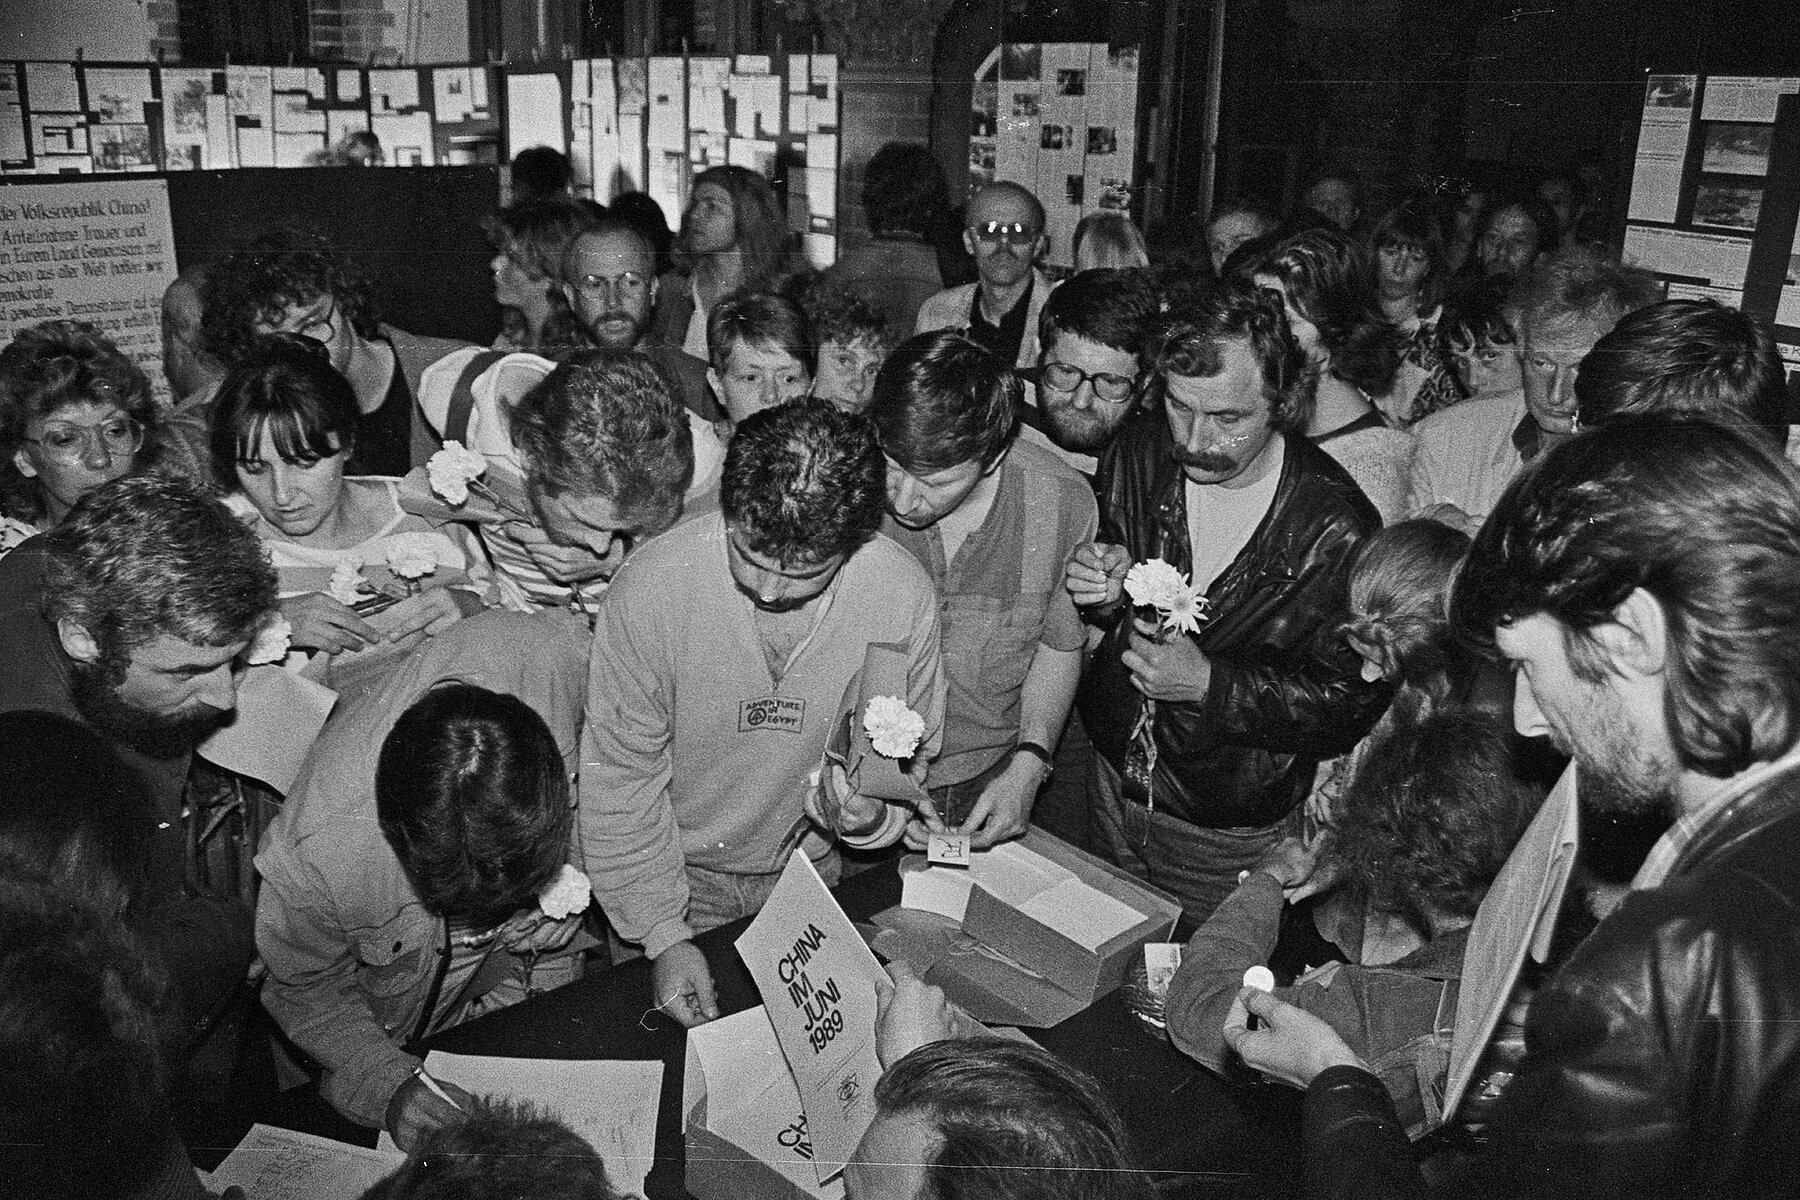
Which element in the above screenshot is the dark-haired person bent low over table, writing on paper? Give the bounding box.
[256,613,587,1150]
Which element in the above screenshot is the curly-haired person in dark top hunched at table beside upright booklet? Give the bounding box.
[1166,711,1539,1137]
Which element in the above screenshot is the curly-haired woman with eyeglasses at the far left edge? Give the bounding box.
[0,320,187,552]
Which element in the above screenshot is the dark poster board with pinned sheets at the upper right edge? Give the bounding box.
[1624,74,1800,390]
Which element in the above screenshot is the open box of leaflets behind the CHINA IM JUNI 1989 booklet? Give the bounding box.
[682,1006,844,1200]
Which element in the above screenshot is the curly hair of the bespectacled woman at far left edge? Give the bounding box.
[0,320,169,522]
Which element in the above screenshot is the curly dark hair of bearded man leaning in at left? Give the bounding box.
[43,475,275,682]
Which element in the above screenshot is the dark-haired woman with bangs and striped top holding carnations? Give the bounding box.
[212,335,488,691]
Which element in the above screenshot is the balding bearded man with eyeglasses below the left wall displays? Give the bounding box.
[562,218,725,423]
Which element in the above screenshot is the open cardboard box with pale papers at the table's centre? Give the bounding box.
[875,829,1181,1029]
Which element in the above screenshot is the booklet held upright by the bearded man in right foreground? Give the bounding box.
[1444,765,1580,1121]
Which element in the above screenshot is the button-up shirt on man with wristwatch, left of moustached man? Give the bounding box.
[882,441,1098,788]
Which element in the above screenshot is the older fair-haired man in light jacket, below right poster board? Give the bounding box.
[1408,248,1656,533]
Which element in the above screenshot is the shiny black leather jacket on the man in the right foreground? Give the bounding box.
[1305,770,1800,1200]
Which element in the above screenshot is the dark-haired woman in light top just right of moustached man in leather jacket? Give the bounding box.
[1255,228,1413,522]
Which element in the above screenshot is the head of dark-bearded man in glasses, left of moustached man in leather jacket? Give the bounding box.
[1021,270,1161,477]
